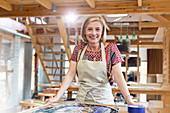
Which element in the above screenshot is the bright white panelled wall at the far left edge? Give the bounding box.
[0,36,24,109]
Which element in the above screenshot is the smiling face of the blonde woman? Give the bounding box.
[85,21,103,44]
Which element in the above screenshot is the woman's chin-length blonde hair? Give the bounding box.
[80,15,108,43]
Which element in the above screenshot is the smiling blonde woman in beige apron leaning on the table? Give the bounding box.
[46,16,142,105]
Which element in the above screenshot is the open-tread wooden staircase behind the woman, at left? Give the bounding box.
[24,17,71,83]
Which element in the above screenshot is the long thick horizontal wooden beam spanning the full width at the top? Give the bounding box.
[0,1,170,17]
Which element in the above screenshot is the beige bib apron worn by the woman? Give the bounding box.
[76,43,114,104]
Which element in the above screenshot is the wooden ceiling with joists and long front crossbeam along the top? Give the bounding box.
[0,0,170,17]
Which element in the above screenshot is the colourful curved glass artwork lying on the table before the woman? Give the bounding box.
[19,102,128,113]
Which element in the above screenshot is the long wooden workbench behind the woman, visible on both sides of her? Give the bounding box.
[38,84,170,108]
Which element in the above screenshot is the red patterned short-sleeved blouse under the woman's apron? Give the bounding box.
[71,43,124,85]
